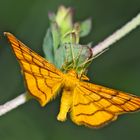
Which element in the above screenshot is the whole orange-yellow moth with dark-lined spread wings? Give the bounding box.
[5,32,140,127]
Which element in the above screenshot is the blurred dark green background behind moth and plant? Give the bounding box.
[0,0,140,140]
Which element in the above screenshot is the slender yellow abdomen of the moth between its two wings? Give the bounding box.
[57,89,73,121]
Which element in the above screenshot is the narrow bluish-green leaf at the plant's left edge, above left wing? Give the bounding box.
[43,29,54,63]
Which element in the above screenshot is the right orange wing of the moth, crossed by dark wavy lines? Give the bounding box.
[71,82,140,127]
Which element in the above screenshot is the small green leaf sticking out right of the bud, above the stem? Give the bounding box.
[80,19,92,37]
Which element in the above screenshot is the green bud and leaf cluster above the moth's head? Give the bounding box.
[43,5,92,74]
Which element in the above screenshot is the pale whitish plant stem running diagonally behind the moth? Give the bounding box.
[0,13,140,116]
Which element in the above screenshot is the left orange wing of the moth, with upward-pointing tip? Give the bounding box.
[4,32,63,106]
